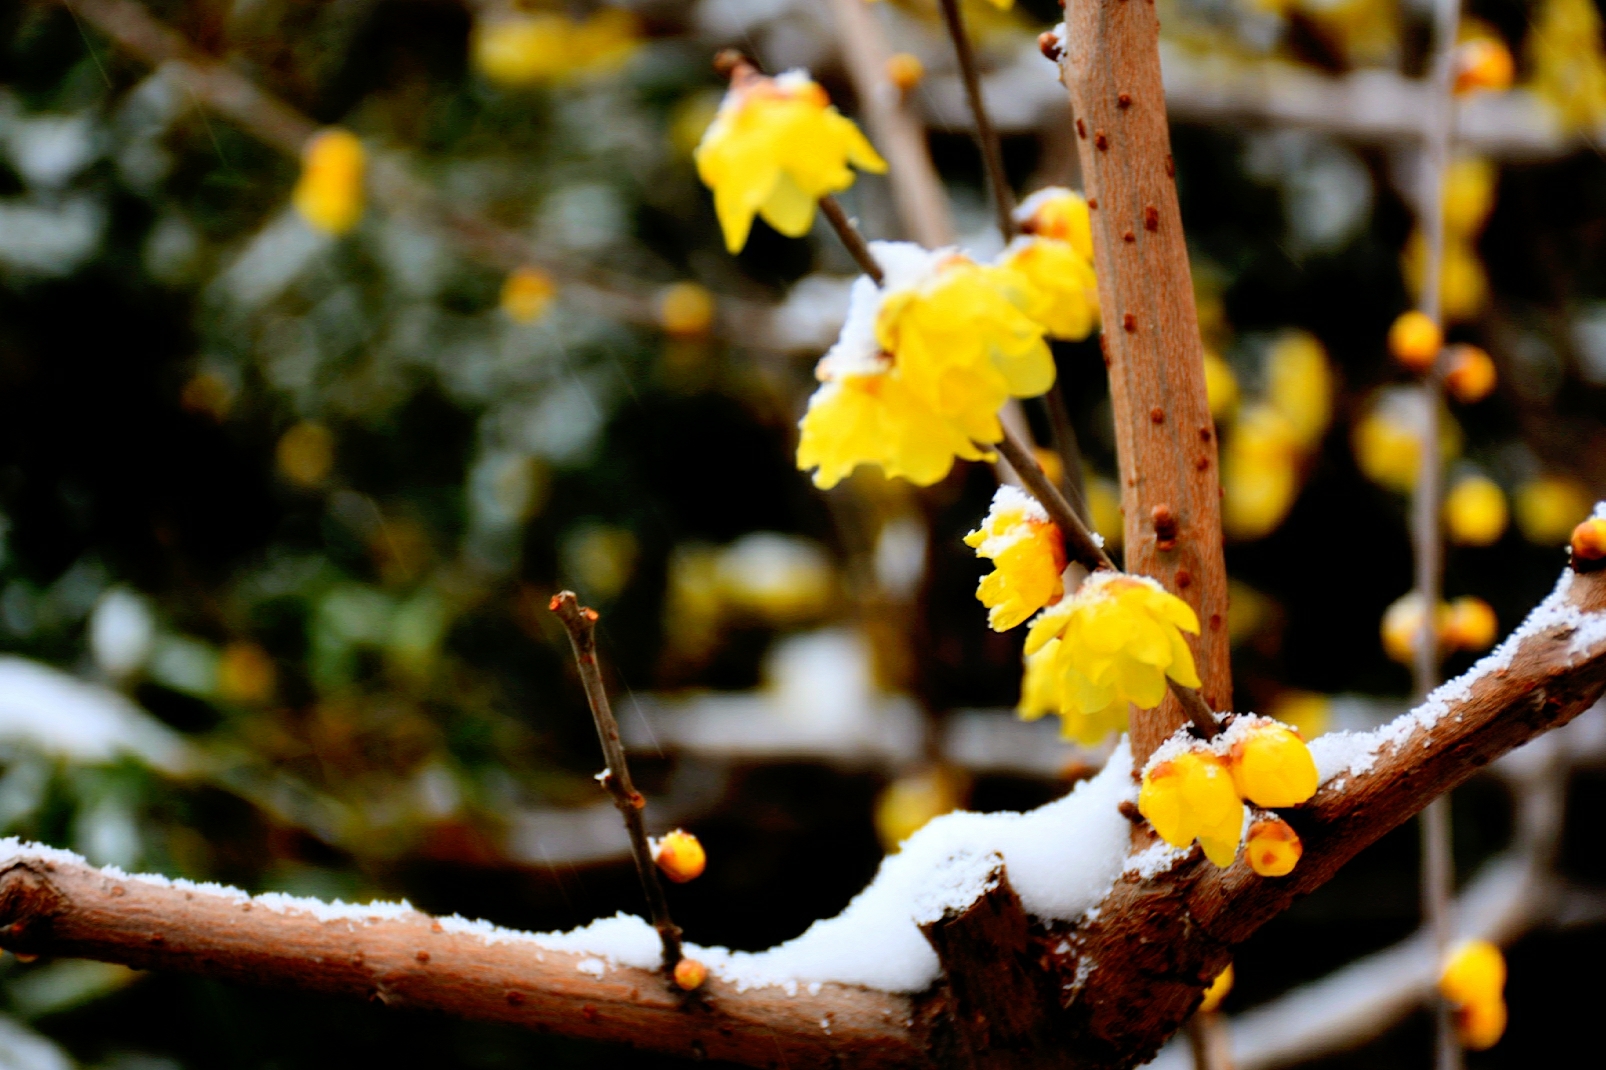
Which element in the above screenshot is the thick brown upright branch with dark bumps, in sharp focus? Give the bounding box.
[1060,0,1232,763]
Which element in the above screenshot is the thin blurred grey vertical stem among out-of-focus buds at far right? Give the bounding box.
[1412,0,1461,1070]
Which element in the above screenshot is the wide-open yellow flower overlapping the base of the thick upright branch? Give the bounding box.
[1026,570,1200,729]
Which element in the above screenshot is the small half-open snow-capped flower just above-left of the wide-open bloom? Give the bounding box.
[965,485,1065,631]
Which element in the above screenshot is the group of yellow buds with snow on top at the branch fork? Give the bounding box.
[1137,717,1319,876]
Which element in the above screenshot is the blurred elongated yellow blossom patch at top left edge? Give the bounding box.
[471,8,641,87]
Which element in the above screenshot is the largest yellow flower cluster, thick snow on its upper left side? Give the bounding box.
[798,241,1054,487]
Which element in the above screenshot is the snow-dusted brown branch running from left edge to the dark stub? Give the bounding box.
[0,848,928,1070]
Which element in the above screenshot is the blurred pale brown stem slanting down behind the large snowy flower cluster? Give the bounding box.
[830,0,954,249]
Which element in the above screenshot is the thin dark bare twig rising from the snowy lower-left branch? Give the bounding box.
[548,591,681,975]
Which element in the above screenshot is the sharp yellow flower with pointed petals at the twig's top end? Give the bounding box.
[694,64,887,252]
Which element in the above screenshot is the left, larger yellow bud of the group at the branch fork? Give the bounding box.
[1137,750,1243,866]
